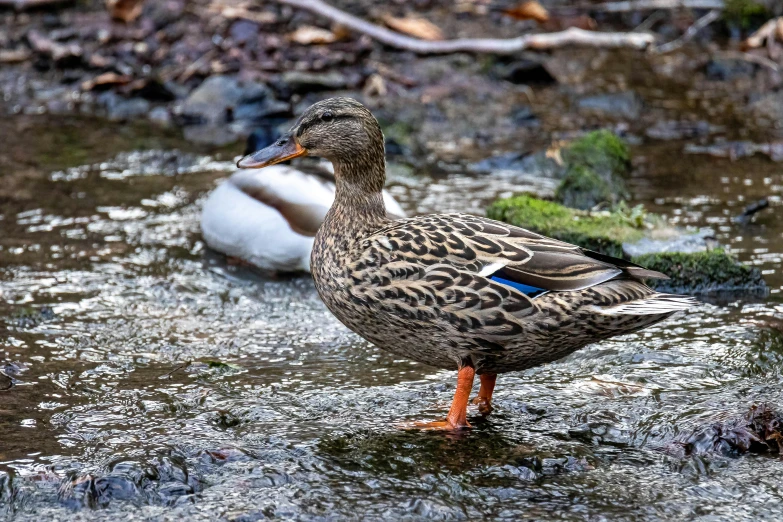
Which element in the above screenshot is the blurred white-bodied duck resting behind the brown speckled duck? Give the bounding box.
[201,130,405,272]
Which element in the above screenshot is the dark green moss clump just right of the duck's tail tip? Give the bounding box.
[631,248,766,293]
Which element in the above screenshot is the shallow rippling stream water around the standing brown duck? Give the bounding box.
[0,115,783,520]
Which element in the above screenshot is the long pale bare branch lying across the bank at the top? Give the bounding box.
[275,0,655,54]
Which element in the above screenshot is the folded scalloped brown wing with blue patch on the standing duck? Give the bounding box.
[349,214,691,353]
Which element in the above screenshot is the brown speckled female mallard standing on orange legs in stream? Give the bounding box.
[238,98,692,429]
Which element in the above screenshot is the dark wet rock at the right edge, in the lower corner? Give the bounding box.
[674,404,783,457]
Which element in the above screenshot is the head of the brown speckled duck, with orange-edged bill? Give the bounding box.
[237,98,385,186]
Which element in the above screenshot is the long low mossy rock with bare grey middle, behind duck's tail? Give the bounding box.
[487,195,767,294]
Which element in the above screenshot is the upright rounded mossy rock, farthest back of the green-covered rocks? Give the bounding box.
[555,130,631,210]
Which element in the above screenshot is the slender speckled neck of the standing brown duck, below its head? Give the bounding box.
[326,154,387,234]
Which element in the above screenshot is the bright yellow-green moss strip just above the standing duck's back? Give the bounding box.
[487,194,644,257]
